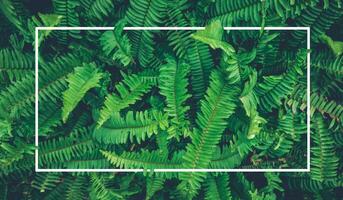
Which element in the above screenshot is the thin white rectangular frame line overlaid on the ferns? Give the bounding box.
[35,27,311,172]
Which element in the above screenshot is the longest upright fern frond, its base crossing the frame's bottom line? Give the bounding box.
[179,71,240,196]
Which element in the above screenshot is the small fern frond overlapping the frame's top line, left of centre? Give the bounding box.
[100,21,133,66]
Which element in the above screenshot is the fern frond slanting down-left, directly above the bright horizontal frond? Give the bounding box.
[97,74,155,128]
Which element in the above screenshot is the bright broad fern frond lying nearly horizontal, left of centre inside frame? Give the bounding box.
[93,111,168,144]
